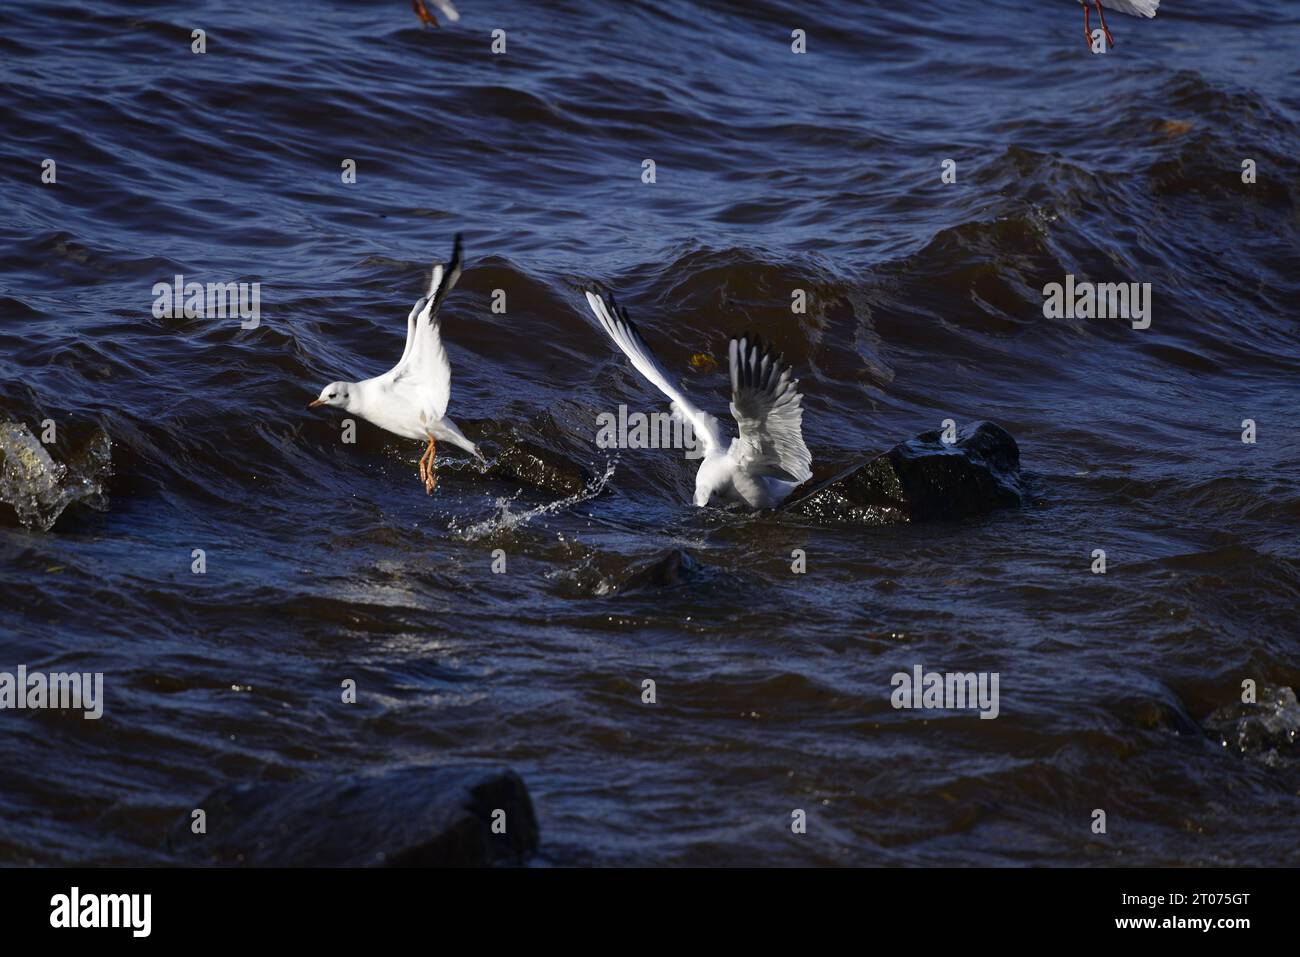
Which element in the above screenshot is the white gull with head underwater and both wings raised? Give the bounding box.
[586,290,813,508]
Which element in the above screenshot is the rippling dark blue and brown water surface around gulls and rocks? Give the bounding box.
[0,0,1300,865]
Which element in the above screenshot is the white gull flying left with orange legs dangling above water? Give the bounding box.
[308,233,485,494]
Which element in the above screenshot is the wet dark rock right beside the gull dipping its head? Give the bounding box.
[780,423,1022,525]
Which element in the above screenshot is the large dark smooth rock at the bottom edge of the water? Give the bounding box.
[166,765,537,867]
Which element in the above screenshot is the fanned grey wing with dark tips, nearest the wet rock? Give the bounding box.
[729,335,813,482]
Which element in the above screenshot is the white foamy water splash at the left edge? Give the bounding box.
[0,423,113,532]
